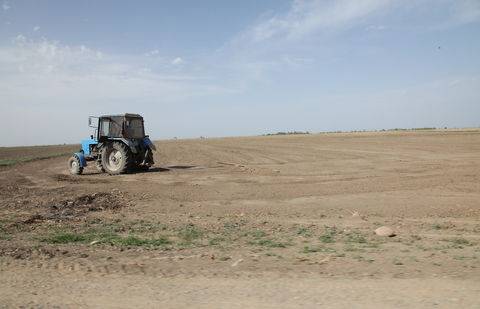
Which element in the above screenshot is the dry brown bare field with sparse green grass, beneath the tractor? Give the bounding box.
[0,130,480,308]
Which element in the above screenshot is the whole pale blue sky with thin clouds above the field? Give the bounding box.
[0,0,480,146]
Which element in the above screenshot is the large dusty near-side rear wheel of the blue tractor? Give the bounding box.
[102,142,132,175]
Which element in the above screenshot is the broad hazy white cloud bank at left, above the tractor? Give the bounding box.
[0,35,233,108]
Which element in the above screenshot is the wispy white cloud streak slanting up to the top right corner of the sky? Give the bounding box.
[222,0,480,81]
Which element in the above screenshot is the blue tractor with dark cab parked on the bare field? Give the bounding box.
[68,114,156,175]
